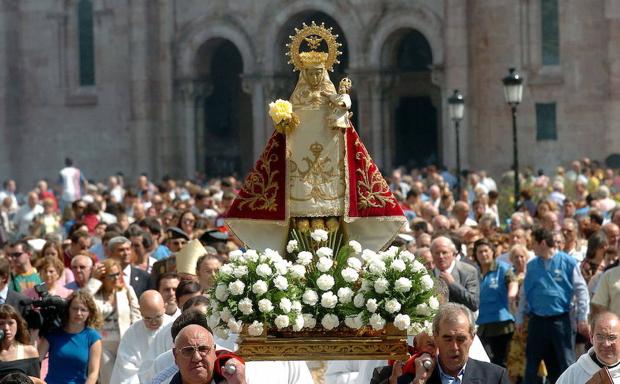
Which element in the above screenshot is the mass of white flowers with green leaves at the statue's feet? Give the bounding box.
[208,236,439,338]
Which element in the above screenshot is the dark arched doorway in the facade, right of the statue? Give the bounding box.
[383,29,441,168]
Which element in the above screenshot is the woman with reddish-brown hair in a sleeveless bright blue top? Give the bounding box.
[39,290,102,384]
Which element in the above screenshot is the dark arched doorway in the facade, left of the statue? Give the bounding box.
[195,38,253,177]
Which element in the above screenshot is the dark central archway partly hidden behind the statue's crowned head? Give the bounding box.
[274,11,357,124]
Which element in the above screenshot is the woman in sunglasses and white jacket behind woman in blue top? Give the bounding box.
[94,259,142,383]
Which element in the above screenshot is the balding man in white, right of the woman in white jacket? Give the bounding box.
[110,290,172,384]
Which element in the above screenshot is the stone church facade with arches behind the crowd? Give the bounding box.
[0,0,620,185]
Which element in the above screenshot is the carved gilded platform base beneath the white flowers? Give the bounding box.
[237,326,408,361]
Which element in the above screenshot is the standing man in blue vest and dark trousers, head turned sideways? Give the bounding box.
[517,228,589,384]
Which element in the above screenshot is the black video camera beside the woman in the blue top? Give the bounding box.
[20,283,67,336]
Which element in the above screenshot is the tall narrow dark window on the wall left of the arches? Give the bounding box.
[78,0,95,86]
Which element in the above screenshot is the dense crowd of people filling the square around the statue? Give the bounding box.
[0,159,620,384]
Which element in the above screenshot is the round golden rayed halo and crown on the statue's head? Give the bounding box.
[286,21,342,71]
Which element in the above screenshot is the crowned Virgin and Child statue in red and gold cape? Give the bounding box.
[226,22,406,252]
